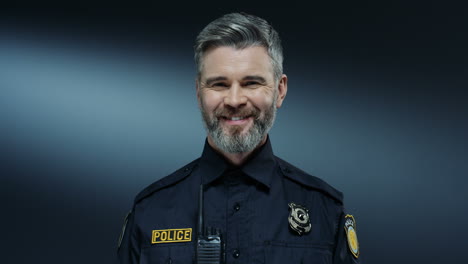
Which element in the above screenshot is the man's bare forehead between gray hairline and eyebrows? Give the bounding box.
[201,46,273,79]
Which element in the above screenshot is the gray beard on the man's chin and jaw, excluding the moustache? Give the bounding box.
[200,93,277,153]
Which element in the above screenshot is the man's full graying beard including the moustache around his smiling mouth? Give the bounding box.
[200,92,278,153]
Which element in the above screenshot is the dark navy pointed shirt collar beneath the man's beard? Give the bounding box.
[198,136,277,188]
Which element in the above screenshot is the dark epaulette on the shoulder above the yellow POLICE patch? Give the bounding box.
[134,158,200,204]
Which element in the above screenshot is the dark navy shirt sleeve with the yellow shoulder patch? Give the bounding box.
[333,213,361,264]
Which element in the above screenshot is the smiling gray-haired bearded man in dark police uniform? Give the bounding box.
[118,13,359,264]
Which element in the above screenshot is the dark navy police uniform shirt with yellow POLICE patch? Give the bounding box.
[118,139,359,264]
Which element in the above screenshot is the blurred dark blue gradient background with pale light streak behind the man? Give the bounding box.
[0,1,468,264]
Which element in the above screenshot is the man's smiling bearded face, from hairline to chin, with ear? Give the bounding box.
[197,46,287,153]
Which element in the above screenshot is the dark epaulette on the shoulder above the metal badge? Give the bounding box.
[276,157,343,204]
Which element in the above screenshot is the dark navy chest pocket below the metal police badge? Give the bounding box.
[265,241,332,264]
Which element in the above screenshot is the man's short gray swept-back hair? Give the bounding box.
[195,13,283,81]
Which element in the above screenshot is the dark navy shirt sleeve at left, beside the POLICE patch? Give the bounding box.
[117,210,140,264]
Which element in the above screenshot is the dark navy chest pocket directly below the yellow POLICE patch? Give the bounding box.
[140,243,195,264]
